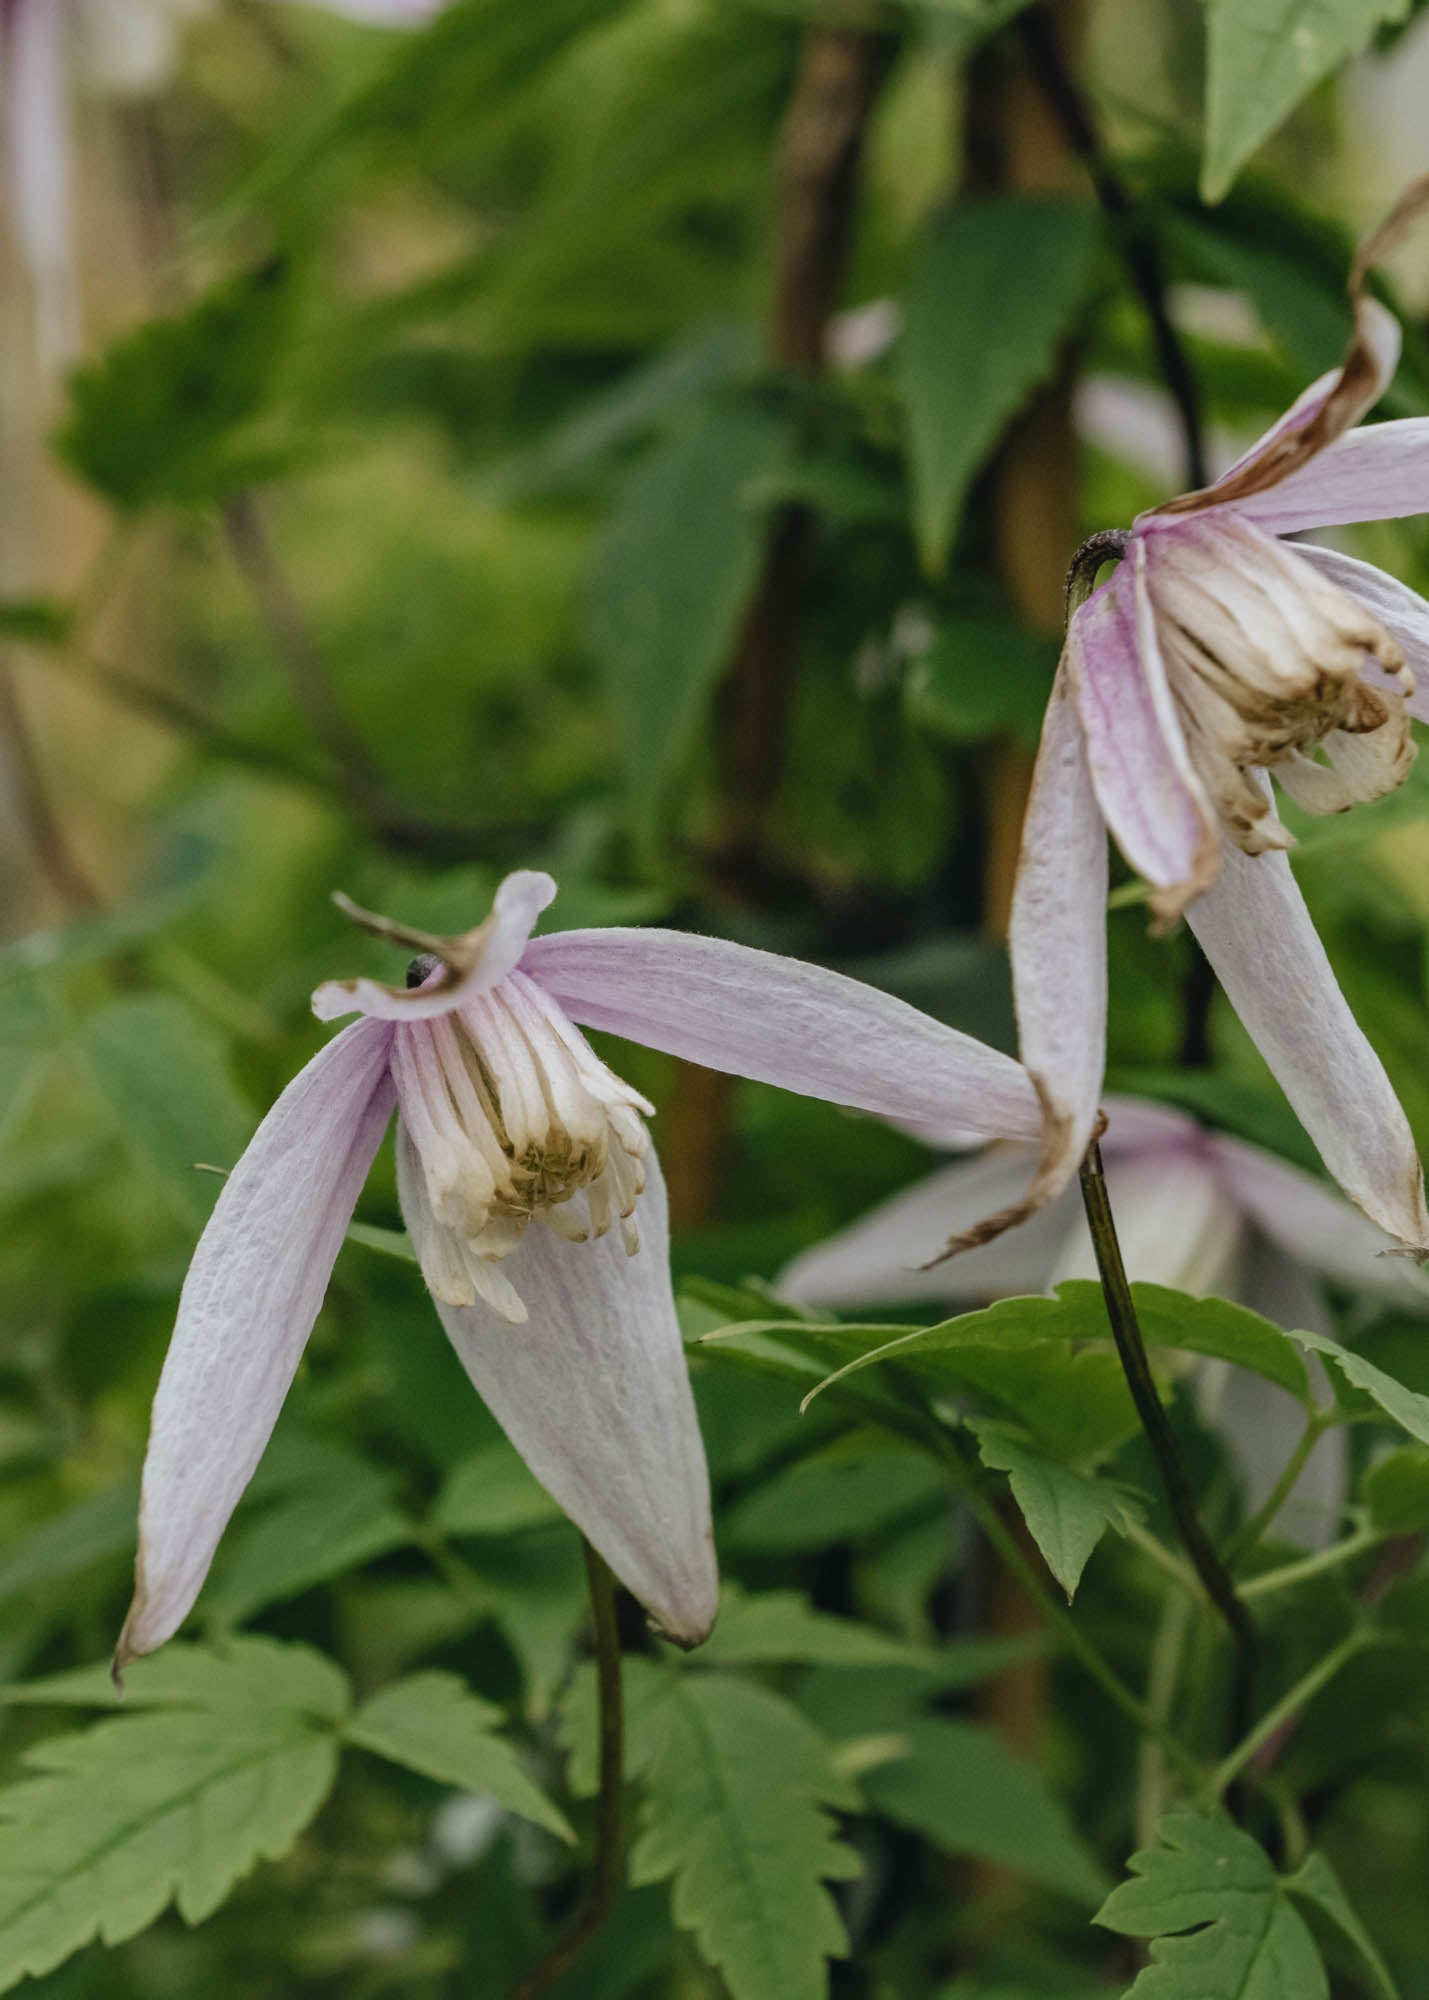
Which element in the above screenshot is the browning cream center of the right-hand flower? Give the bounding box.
[1147,514,1415,854]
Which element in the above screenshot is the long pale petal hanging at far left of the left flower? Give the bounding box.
[114,1022,392,1666]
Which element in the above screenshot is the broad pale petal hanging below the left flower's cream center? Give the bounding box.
[418,1154,719,1646]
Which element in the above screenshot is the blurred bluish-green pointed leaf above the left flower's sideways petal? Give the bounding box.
[584,398,791,830]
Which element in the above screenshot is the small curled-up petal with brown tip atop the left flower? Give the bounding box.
[312,868,556,1020]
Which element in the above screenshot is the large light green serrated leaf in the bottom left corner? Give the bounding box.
[0,1706,338,1990]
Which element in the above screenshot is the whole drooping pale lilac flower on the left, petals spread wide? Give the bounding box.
[118,872,1041,1664]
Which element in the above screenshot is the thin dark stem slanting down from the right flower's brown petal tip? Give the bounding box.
[1081,1140,1257,1738]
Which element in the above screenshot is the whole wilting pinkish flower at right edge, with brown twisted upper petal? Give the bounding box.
[968,184,1429,1256]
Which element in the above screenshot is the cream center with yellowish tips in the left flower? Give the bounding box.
[392,972,650,1322]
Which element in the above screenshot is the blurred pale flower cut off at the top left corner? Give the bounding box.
[0,0,444,362]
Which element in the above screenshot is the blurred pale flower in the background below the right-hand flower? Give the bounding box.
[779,1096,1429,1544]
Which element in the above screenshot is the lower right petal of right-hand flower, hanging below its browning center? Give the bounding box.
[1187,780,1429,1256]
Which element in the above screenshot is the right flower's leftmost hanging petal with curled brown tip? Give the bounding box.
[1009,674,1107,1204]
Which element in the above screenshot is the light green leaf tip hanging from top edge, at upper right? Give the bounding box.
[1201,0,1409,202]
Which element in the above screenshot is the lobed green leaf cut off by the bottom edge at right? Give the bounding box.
[1095,1812,1329,2000]
